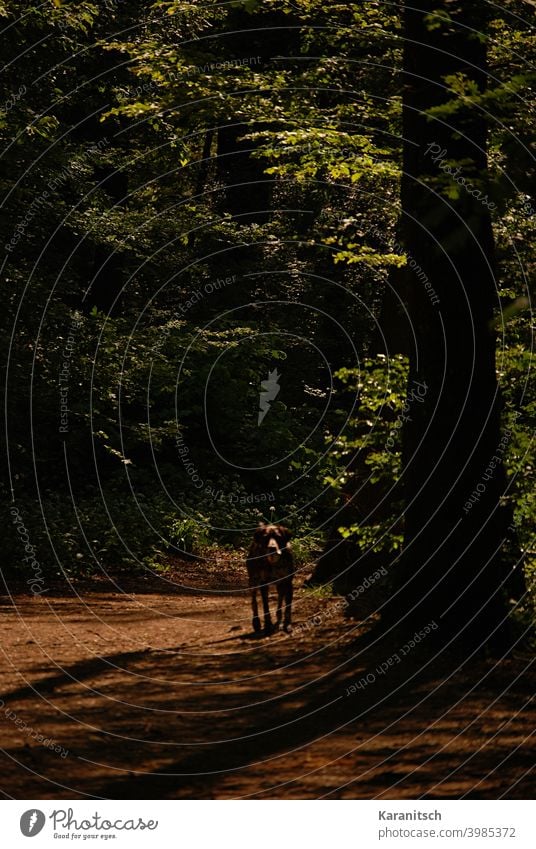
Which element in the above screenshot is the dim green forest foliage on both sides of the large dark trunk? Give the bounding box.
[0,0,536,608]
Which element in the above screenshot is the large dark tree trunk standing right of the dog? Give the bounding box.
[392,0,524,644]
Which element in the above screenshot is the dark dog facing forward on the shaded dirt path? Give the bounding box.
[246,522,294,634]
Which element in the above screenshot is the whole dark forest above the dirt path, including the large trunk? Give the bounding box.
[0,0,536,644]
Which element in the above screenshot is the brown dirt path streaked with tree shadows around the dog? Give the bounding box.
[0,556,536,799]
